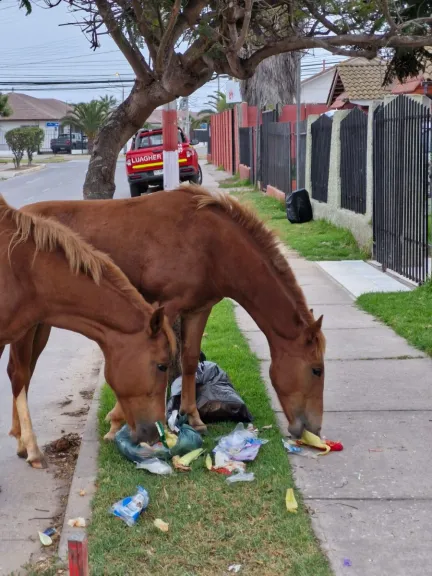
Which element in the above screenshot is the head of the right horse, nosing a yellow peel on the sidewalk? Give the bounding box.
[270,316,325,438]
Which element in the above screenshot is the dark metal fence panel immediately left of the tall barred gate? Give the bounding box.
[340,108,368,214]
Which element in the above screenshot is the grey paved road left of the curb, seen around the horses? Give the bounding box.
[0,160,115,576]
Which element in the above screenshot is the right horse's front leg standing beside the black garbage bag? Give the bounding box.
[180,308,211,433]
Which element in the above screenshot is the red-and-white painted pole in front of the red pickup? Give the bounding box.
[162,100,180,190]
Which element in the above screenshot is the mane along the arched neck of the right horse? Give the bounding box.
[187,186,325,354]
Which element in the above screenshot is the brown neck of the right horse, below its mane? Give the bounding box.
[224,243,307,344]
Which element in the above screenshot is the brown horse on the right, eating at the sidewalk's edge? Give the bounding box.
[10,187,325,456]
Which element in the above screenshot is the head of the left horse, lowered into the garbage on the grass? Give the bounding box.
[105,308,175,442]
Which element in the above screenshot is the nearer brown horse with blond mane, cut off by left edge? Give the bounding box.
[0,196,175,468]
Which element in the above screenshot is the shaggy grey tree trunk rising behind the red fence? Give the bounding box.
[240,52,298,108]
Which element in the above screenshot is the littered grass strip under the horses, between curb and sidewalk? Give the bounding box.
[90,300,331,576]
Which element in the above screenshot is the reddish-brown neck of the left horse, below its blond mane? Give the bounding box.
[20,248,146,346]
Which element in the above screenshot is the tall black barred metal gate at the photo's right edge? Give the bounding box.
[373,96,431,283]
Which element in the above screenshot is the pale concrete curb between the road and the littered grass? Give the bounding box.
[58,361,105,561]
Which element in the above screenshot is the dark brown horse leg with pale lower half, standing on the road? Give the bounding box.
[8,324,51,468]
